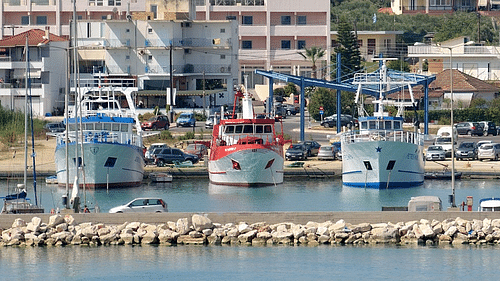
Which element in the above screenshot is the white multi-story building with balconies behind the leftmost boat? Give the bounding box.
[77,20,238,108]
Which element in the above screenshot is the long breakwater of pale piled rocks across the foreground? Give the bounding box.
[0,214,500,246]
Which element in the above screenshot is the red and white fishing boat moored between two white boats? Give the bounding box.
[208,85,285,186]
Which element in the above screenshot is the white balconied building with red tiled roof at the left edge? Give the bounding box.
[0,29,69,116]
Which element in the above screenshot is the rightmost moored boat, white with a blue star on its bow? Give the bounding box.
[341,61,424,189]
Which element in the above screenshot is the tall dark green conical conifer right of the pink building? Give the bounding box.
[332,19,361,80]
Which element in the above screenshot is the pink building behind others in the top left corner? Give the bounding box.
[0,0,145,38]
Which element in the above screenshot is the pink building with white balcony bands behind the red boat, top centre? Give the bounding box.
[193,0,331,88]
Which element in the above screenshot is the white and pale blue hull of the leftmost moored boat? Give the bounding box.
[55,143,144,188]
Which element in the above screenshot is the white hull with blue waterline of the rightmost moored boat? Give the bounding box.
[342,141,425,189]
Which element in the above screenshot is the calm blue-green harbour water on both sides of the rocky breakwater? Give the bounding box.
[0,179,500,280]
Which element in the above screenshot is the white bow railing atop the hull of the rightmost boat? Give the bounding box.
[341,130,424,145]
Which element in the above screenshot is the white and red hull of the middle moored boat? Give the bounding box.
[208,145,284,187]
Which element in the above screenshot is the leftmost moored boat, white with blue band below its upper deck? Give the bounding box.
[55,75,144,188]
